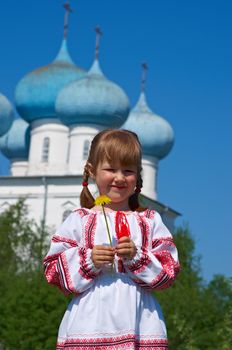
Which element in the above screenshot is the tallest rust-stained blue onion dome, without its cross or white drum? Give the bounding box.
[15,39,86,122]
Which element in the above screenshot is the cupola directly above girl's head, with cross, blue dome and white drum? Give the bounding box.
[56,27,130,174]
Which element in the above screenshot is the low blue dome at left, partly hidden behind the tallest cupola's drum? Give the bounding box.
[0,118,30,160]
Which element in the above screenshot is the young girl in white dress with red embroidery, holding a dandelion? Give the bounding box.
[44,129,179,350]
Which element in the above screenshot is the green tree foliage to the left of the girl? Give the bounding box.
[0,200,67,350]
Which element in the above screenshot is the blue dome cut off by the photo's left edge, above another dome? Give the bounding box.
[0,93,14,136]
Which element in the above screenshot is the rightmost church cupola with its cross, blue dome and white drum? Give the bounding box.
[122,64,174,199]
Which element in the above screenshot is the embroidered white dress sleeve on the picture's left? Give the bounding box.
[44,212,101,294]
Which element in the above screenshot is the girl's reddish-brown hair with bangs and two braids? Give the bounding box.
[80,129,144,211]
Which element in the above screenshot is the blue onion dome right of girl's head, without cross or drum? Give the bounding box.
[122,92,174,159]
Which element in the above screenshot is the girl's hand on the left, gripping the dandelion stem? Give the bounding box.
[91,245,115,269]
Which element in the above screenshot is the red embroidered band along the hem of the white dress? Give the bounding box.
[56,334,168,350]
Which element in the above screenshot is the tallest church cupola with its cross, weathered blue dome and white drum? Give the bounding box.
[15,1,82,175]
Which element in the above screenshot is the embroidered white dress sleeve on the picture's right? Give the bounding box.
[123,211,180,290]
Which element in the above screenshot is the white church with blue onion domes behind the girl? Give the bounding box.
[0,2,180,230]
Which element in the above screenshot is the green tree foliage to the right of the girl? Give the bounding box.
[156,227,232,350]
